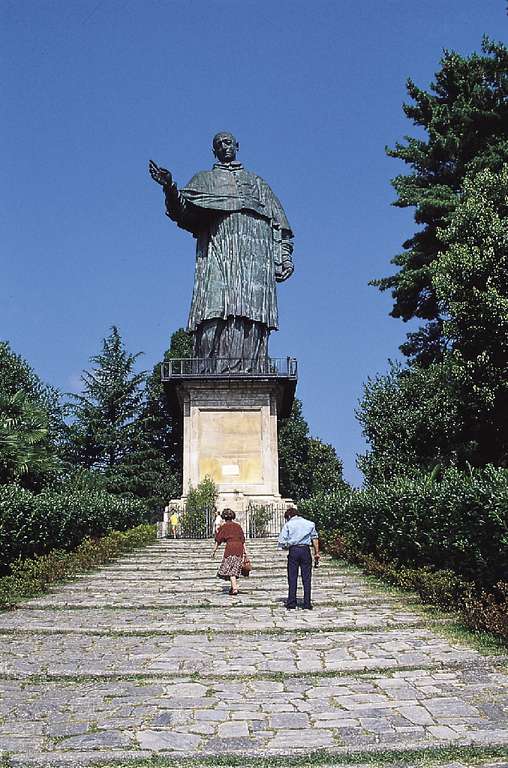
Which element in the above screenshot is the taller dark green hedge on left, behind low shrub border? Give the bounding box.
[0,485,148,574]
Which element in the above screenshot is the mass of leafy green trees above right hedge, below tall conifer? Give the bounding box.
[358,165,508,483]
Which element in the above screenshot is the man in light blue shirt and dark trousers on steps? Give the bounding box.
[278,507,319,610]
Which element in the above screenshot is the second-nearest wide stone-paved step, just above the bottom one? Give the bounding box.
[0,629,477,678]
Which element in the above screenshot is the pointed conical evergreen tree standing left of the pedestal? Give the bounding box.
[68,326,146,471]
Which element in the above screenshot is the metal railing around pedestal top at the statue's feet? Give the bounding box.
[161,357,298,381]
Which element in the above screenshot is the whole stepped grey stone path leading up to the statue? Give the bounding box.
[0,541,508,766]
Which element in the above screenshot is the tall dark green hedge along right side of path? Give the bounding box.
[299,467,508,587]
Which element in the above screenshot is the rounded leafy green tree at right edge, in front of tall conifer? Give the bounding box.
[432,165,508,466]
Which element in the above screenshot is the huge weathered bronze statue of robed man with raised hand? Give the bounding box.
[149,133,293,371]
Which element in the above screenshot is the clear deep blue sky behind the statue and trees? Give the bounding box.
[0,0,506,483]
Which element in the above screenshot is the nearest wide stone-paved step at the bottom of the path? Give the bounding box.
[0,666,508,765]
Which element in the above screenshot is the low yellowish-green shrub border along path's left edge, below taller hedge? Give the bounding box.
[0,525,157,610]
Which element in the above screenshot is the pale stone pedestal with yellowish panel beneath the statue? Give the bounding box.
[163,358,296,524]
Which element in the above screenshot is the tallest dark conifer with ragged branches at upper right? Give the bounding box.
[373,38,508,365]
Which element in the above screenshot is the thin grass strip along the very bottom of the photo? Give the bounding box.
[4,746,508,768]
